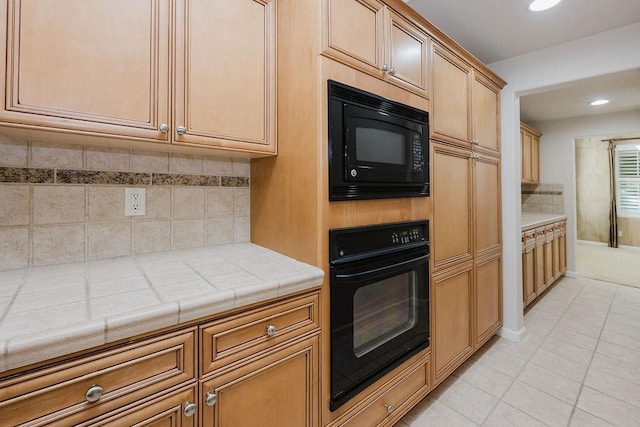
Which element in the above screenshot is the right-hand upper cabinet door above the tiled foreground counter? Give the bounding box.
[174,0,276,152]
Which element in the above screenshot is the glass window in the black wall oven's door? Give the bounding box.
[353,271,418,357]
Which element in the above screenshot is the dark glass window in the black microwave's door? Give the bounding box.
[356,127,407,165]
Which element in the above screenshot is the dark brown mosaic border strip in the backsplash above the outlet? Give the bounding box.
[0,167,249,187]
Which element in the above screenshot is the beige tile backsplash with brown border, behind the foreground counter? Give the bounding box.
[0,136,250,271]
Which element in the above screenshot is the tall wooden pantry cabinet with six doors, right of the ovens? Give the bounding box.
[430,43,503,384]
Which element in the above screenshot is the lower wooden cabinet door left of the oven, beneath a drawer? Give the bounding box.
[200,336,319,427]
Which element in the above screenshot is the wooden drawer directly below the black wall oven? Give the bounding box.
[342,359,429,427]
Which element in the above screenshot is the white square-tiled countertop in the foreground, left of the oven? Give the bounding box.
[0,243,324,372]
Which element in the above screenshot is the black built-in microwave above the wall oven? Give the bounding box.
[328,80,429,201]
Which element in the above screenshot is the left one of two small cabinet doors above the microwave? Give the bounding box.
[322,0,385,78]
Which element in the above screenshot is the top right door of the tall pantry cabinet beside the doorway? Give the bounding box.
[471,71,500,155]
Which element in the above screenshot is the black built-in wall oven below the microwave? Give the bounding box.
[329,221,429,411]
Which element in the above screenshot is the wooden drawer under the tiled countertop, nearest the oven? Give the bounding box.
[200,293,319,375]
